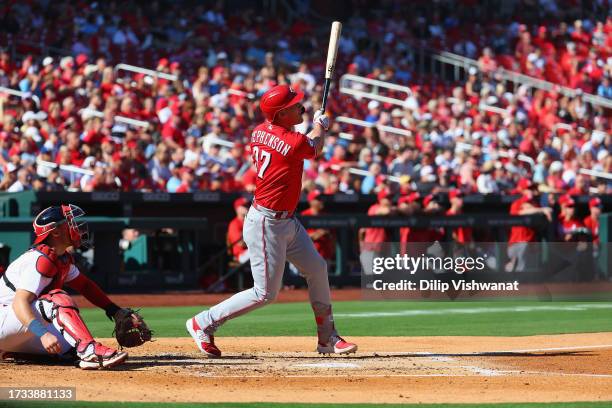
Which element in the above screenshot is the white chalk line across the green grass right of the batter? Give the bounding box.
[334,303,612,318]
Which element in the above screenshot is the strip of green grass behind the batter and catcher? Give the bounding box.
[82,301,612,337]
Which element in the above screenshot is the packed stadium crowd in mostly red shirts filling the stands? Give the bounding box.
[0,0,612,202]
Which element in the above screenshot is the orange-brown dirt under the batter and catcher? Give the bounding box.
[0,333,612,403]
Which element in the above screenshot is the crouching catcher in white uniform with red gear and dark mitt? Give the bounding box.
[0,204,151,370]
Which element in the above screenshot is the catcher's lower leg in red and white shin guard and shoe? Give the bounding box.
[39,289,128,370]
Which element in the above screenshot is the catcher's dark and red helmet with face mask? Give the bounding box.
[32,204,91,249]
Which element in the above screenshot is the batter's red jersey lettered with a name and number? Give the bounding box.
[250,122,316,212]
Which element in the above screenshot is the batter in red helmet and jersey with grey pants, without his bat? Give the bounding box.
[186,85,357,357]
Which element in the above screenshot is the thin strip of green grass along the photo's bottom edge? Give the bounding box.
[0,401,610,408]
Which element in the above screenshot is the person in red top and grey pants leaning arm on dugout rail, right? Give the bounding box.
[506,178,552,272]
